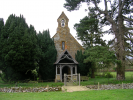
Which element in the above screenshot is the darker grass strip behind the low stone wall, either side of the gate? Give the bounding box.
[0,72,133,87]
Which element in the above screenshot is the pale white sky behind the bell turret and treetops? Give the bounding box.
[0,0,112,44]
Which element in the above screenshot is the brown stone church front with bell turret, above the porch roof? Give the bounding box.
[53,12,83,59]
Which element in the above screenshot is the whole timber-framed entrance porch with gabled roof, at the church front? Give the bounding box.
[55,49,78,82]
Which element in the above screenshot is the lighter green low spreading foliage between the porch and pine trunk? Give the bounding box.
[84,46,118,69]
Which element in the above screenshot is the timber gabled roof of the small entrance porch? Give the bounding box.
[54,49,78,64]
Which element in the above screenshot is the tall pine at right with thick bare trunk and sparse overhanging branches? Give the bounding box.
[64,0,133,80]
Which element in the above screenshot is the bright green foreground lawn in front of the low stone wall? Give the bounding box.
[0,89,133,100]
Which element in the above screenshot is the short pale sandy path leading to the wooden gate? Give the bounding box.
[62,86,89,92]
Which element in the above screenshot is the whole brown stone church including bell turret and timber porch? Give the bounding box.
[53,12,83,82]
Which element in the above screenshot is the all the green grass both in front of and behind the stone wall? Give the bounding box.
[0,72,133,100]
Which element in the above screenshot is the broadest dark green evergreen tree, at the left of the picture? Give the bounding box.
[0,15,38,81]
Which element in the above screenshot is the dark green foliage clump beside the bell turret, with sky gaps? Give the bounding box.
[74,14,106,48]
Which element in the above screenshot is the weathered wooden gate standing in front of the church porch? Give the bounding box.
[64,73,80,86]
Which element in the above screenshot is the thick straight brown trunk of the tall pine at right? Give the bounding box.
[115,16,125,80]
